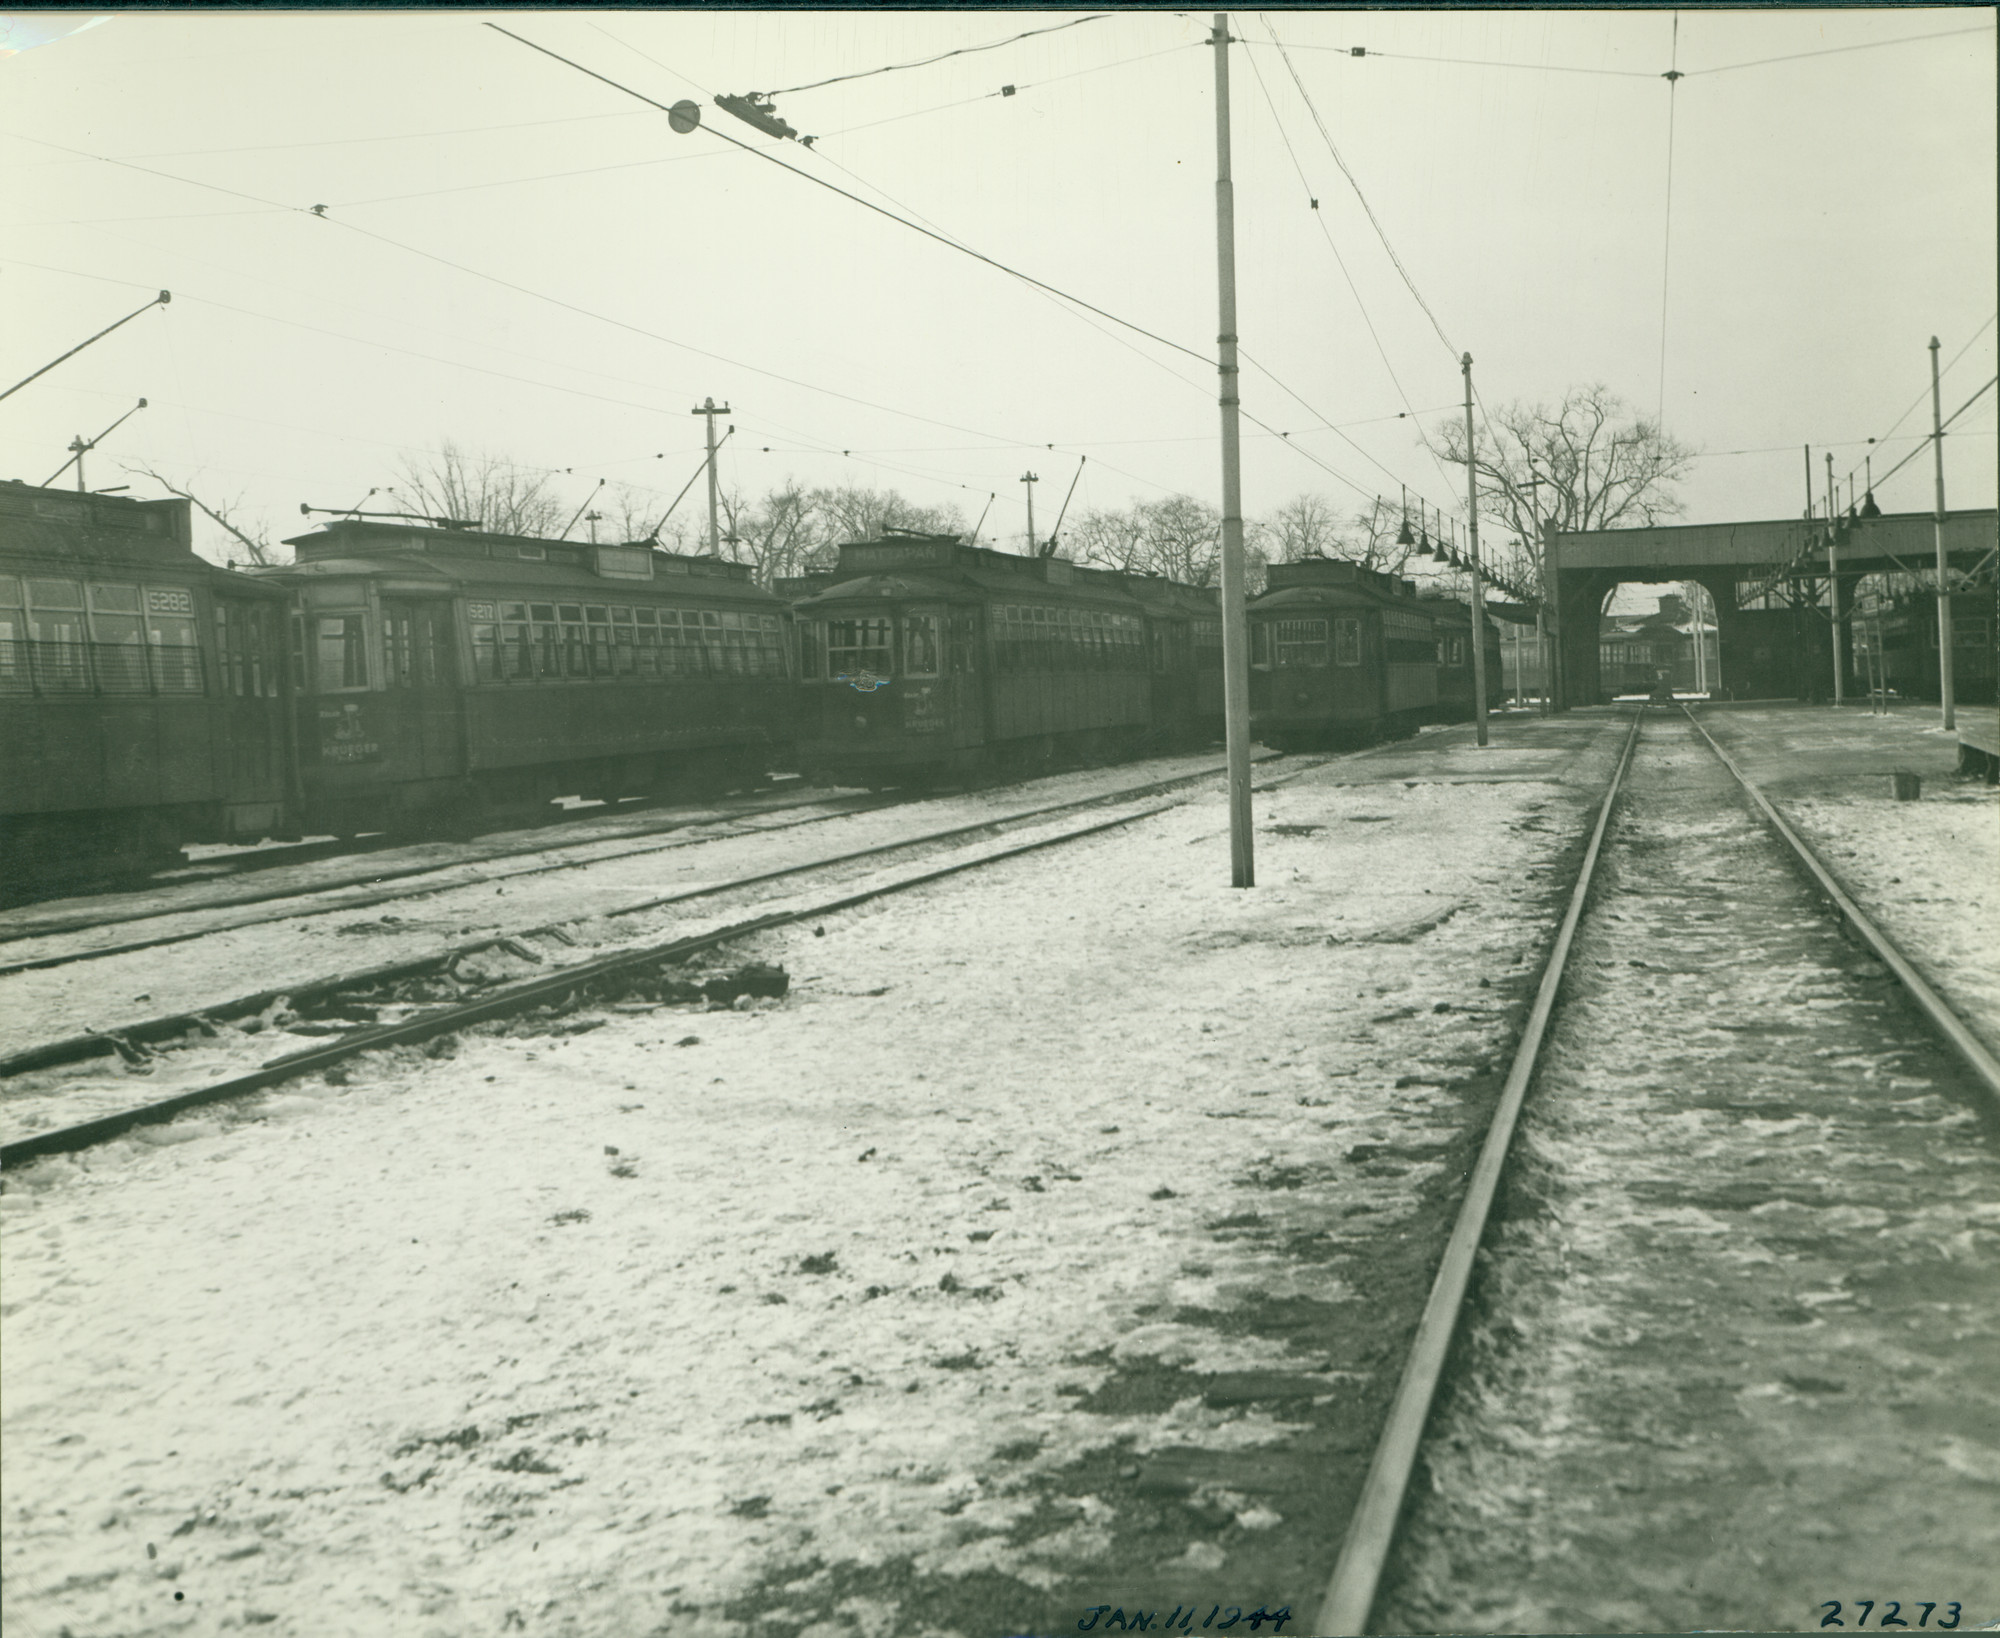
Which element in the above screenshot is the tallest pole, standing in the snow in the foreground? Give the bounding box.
[1210,12,1256,888]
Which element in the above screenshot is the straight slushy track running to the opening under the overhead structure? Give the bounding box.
[1312,710,2000,1634]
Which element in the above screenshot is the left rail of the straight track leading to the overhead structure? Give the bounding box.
[1312,706,1646,1638]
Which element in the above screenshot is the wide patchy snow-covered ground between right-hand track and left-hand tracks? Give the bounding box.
[0,720,1622,1638]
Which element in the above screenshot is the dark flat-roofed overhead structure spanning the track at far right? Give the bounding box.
[1544,508,2000,706]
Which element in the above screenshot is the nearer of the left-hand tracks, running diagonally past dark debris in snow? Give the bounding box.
[0,758,1360,1166]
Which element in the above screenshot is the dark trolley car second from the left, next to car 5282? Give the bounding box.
[262,520,794,836]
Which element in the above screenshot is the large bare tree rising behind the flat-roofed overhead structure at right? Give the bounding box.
[1436,382,1694,540]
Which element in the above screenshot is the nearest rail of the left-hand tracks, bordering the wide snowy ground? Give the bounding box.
[0,802,1178,1168]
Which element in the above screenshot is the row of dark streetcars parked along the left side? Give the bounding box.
[0,482,1498,894]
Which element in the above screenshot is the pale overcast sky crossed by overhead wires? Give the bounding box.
[0,8,2000,572]
